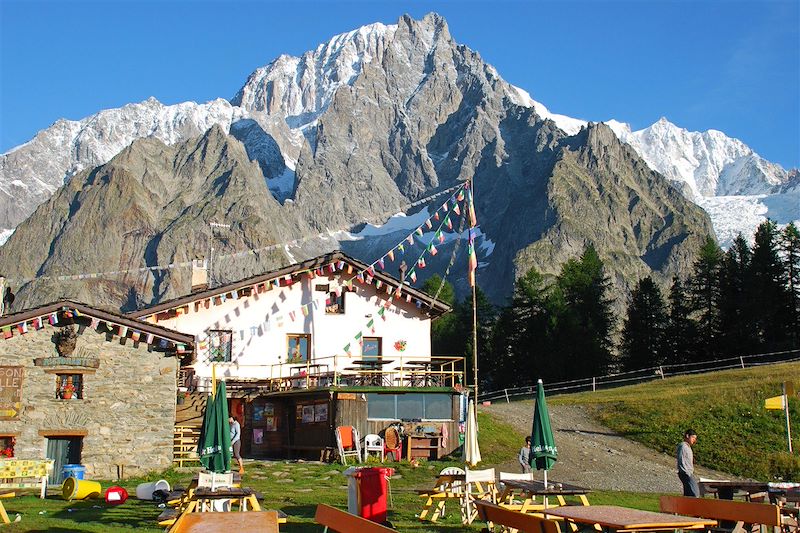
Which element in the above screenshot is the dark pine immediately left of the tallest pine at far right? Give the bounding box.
[720,234,758,356]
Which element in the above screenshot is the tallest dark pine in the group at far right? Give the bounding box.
[750,219,790,352]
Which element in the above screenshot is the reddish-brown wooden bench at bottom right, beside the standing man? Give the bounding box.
[659,496,781,533]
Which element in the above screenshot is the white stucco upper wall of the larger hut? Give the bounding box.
[136,260,438,379]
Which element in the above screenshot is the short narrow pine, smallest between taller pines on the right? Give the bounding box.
[665,276,699,365]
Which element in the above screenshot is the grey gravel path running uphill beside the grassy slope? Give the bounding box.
[480,401,730,493]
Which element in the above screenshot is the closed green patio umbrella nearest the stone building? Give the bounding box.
[197,381,231,473]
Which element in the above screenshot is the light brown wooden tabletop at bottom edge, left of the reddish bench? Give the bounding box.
[547,505,717,532]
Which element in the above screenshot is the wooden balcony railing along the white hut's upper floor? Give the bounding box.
[191,355,464,391]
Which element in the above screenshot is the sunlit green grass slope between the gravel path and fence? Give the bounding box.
[548,362,800,481]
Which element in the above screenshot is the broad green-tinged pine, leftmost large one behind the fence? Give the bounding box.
[553,245,614,377]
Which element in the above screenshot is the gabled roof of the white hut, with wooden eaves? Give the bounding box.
[128,250,451,318]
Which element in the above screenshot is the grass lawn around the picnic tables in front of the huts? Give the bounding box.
[2,460,658,533]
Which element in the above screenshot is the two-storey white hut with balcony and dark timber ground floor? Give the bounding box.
[130,252,464,464]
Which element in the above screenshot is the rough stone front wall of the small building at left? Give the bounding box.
[0,325,177,479]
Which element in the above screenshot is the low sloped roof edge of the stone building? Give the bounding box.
[0,300,194,346]
